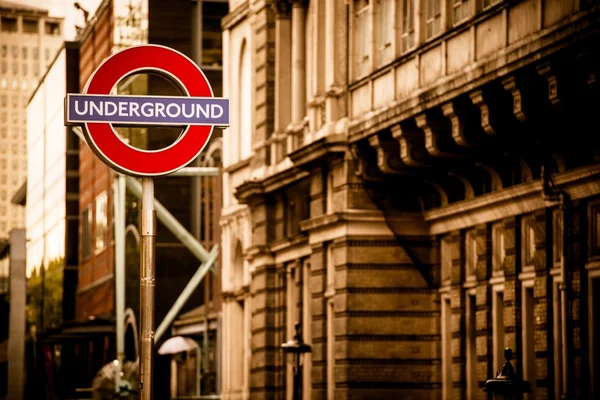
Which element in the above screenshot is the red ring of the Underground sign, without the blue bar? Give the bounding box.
[83,45,213,176]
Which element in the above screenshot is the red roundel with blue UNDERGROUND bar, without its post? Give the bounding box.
[65,45,229,176]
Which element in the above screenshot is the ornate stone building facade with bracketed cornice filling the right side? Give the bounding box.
[222,0,600,399]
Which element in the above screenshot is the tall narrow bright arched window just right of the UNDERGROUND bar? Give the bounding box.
[238,40,253,160]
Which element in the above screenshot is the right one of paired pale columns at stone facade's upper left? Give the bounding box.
[292,0,306,124]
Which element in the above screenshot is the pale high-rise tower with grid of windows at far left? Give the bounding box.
[0,1,63,237]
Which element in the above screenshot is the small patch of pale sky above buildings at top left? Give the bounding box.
[25,0,101,40]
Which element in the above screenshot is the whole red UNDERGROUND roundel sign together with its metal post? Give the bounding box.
[65,45,229,400]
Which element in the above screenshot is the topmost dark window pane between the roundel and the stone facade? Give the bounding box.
[202,1,229,67]
